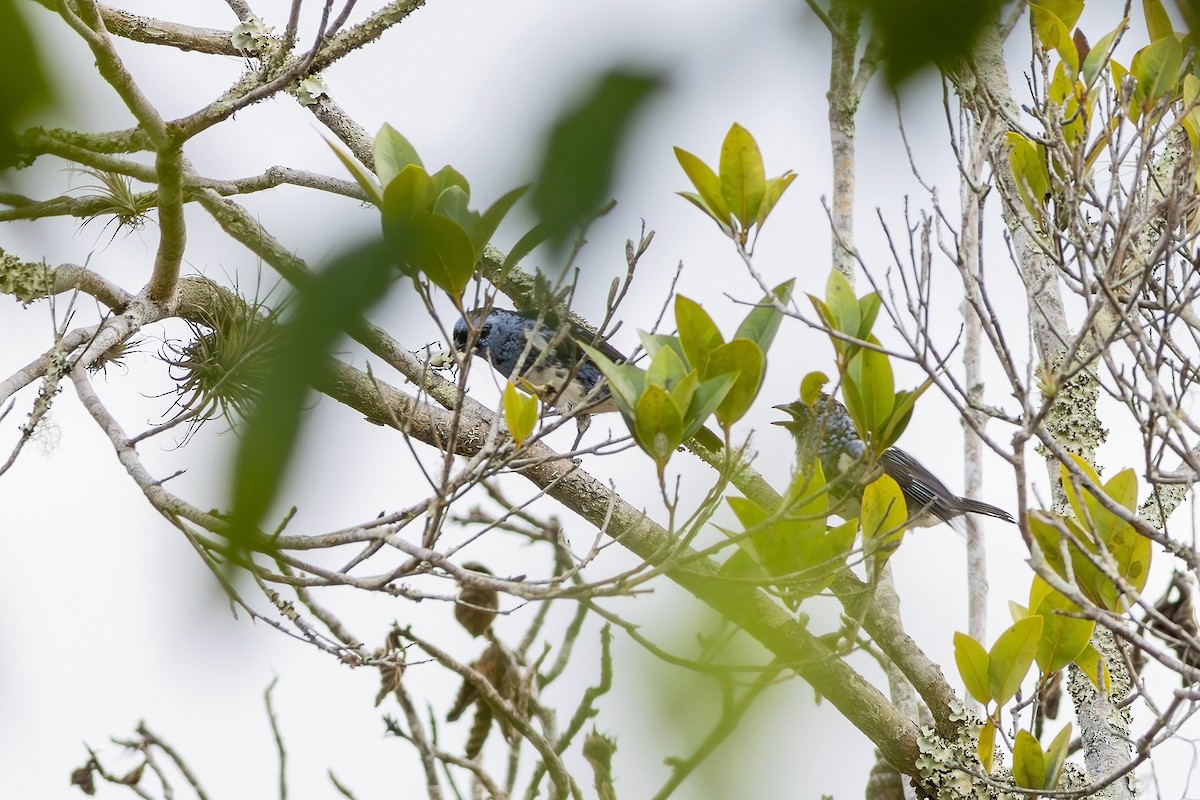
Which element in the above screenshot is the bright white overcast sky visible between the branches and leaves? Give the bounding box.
[0,0,1182,800]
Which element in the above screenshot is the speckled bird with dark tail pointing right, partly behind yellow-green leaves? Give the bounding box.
[775,392,1015,528]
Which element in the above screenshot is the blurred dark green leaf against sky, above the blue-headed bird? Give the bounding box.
[533,70,662,248]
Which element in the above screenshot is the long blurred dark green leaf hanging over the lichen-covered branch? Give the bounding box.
[229,241,395,561]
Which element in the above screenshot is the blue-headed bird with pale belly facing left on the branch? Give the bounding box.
[452,307,625,446]
